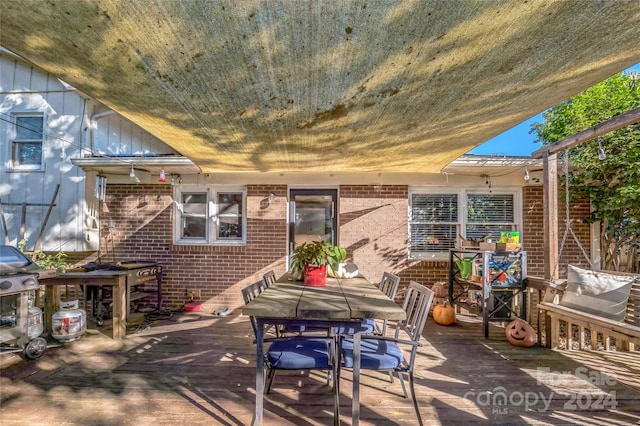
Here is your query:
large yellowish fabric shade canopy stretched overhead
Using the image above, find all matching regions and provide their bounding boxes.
[0,0,640,173]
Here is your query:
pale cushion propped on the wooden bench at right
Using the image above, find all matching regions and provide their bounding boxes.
[560,265,635,321]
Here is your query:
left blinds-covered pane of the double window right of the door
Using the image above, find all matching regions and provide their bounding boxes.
[409,194,459,256]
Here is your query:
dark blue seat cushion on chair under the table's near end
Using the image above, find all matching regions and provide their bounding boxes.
[267,340,331,370]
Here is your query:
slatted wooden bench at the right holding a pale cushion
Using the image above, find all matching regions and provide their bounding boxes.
[538,274,640,351]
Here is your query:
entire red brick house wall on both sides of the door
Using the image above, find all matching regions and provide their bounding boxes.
[100,184,589,312]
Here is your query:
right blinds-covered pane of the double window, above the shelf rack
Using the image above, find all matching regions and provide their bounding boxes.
[465,194,517,241]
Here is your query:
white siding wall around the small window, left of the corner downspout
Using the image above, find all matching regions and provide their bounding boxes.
[0,52,89,251]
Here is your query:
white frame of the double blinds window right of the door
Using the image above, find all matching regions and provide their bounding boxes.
[407,187,523,260]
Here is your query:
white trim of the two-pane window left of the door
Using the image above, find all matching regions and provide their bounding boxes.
[173,184,247,246]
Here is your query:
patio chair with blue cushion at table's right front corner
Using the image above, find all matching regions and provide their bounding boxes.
[340,281,434,425]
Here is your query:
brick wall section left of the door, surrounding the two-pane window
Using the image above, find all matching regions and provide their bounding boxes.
[101,185,287,312]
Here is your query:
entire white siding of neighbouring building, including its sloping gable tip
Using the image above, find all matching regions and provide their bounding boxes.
[0,50,175,252]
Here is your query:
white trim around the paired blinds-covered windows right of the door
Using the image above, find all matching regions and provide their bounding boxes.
[407,187,523,260]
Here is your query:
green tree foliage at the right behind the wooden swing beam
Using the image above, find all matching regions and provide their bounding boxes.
[531,73,640,270]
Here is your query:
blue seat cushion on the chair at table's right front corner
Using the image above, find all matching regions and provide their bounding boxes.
[342,339,404,370]
